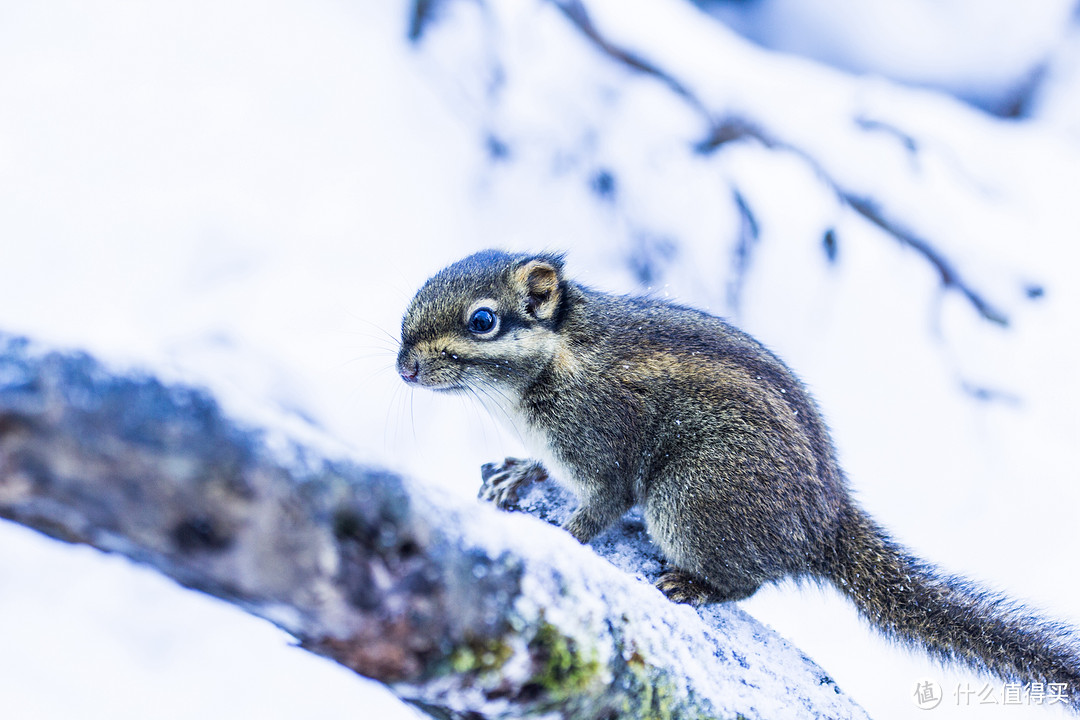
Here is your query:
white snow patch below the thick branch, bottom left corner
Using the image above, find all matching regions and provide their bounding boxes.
[0,522,422,719]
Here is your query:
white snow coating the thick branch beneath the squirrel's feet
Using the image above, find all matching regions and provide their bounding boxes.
[435,480,865,718]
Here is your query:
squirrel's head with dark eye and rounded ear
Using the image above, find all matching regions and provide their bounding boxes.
[397,250,566,393]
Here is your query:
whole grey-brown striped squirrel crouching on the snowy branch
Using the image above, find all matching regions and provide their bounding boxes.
[396,250,1080,712]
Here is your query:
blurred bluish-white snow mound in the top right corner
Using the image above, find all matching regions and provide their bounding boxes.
[699,0,1076,110]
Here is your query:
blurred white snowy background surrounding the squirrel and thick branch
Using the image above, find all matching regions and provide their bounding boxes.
[0,0,1080,720]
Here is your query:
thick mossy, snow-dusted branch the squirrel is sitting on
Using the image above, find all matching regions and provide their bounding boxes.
[0,336,865,718]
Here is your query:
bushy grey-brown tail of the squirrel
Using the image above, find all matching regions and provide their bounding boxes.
[825,505,1080,714]
